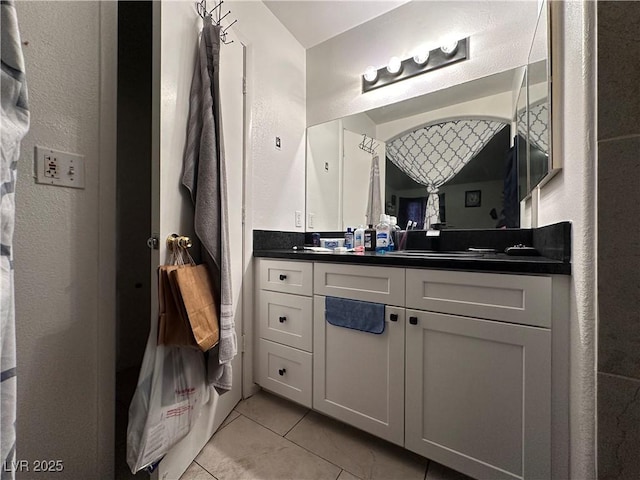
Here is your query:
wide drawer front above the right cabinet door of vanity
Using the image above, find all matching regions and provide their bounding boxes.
[407,269,551,328]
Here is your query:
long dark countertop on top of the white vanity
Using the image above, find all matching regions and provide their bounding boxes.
[253,249,571,275]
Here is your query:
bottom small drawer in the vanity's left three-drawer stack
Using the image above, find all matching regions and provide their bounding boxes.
[258,338,312,408]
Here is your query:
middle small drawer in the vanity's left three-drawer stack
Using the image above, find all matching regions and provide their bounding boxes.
[256,290,313,352]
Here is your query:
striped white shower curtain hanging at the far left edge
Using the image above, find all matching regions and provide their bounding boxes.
[0,0,29,480]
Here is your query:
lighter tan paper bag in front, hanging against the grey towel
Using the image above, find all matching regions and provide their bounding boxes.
[169,265,220,352]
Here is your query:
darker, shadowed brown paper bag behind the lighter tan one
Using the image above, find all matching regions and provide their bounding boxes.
[158,265,198,348]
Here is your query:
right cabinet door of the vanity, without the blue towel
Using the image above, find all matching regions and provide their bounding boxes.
[405,309,551,480]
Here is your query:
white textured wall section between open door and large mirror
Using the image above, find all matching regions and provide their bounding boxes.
[231,1,306,232]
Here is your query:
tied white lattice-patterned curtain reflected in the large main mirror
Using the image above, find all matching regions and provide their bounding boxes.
[387,120,506,228]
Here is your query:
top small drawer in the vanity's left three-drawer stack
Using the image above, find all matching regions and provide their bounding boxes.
[257,258,313,296]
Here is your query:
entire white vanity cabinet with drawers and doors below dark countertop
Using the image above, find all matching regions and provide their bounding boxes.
[256,259,568,480]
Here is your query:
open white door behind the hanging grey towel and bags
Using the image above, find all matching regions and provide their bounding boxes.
[151,1,244,479]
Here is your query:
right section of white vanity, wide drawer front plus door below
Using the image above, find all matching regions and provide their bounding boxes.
[405,269,551,480]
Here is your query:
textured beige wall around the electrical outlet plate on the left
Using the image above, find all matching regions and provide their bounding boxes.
[15,2,115,479]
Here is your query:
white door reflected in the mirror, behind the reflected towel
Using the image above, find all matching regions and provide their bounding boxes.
[342,129,386,230]
